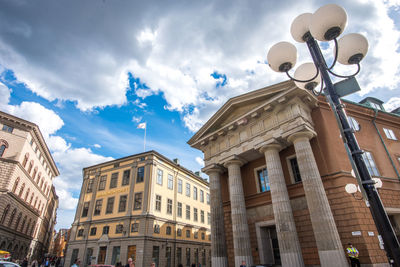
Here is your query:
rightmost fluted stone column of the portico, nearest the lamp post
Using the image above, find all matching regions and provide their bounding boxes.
[288,132,348,267]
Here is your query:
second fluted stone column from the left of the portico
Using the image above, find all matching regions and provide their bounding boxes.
[224,157,253,267]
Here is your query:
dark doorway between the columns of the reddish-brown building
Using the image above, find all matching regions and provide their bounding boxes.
[259,226,281,265]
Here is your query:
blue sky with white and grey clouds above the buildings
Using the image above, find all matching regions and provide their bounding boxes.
[0,0,400,229]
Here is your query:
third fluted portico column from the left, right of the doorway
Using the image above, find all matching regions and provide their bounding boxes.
[260,144,304,267]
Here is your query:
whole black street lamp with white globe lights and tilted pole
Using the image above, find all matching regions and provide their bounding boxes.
[267,4,400,267]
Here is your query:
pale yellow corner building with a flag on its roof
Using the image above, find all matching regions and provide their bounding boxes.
[65,151,210,266]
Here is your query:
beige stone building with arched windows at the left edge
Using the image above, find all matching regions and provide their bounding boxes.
[0,112,59,259]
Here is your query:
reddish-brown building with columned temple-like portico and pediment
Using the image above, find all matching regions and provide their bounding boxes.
[188,81,400,267]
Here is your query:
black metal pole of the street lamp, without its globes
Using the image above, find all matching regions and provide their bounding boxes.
[306,35,400,267]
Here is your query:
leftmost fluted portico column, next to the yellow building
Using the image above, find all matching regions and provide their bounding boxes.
[202,164,228,267]
